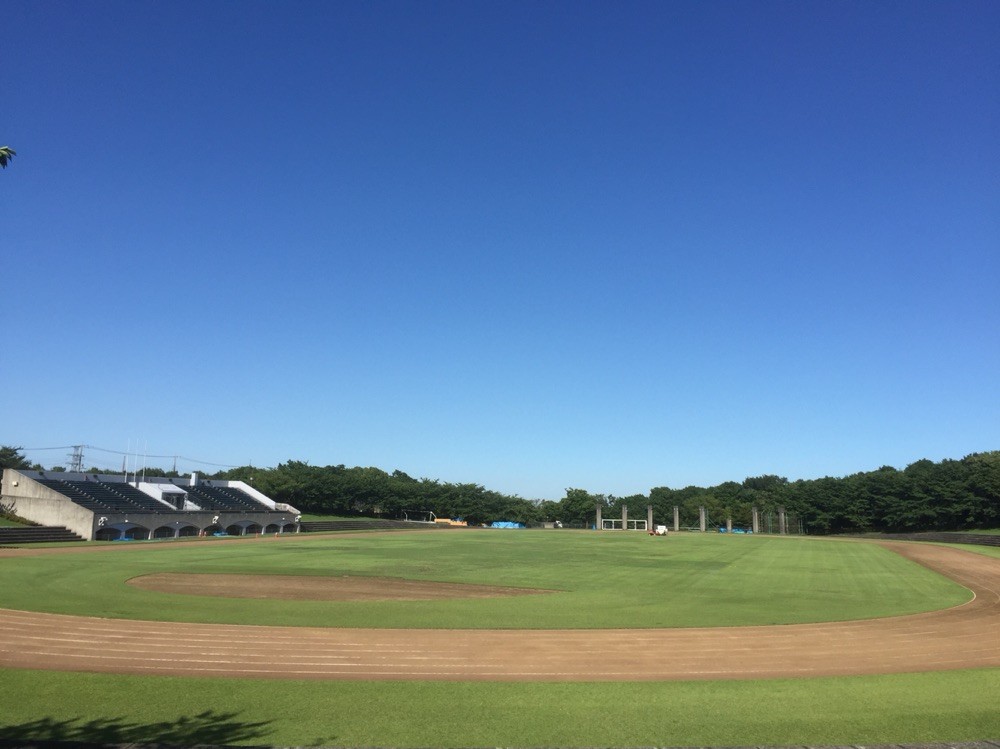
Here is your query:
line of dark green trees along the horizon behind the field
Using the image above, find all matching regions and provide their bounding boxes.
[0,447,1000,534]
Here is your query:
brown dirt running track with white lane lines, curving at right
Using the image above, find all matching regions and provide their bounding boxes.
[0,543,1000,681]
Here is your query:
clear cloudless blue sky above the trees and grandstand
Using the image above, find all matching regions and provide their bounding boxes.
[0,0,1000,499]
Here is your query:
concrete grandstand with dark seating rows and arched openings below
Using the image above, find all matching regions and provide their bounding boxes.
[2,468,300,541]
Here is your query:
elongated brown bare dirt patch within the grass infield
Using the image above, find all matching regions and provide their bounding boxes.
[128,572,552,601]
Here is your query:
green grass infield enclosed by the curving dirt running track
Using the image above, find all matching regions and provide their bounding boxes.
[0,531,969,628]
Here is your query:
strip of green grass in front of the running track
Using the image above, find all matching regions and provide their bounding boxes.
[0,669,1000,747]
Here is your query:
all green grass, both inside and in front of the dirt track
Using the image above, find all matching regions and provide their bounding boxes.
[0,531,1000,747]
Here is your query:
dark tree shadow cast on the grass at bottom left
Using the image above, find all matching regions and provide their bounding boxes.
[0,710,271,749]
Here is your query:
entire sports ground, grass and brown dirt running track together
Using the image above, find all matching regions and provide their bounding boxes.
[0,531,1000,746]
